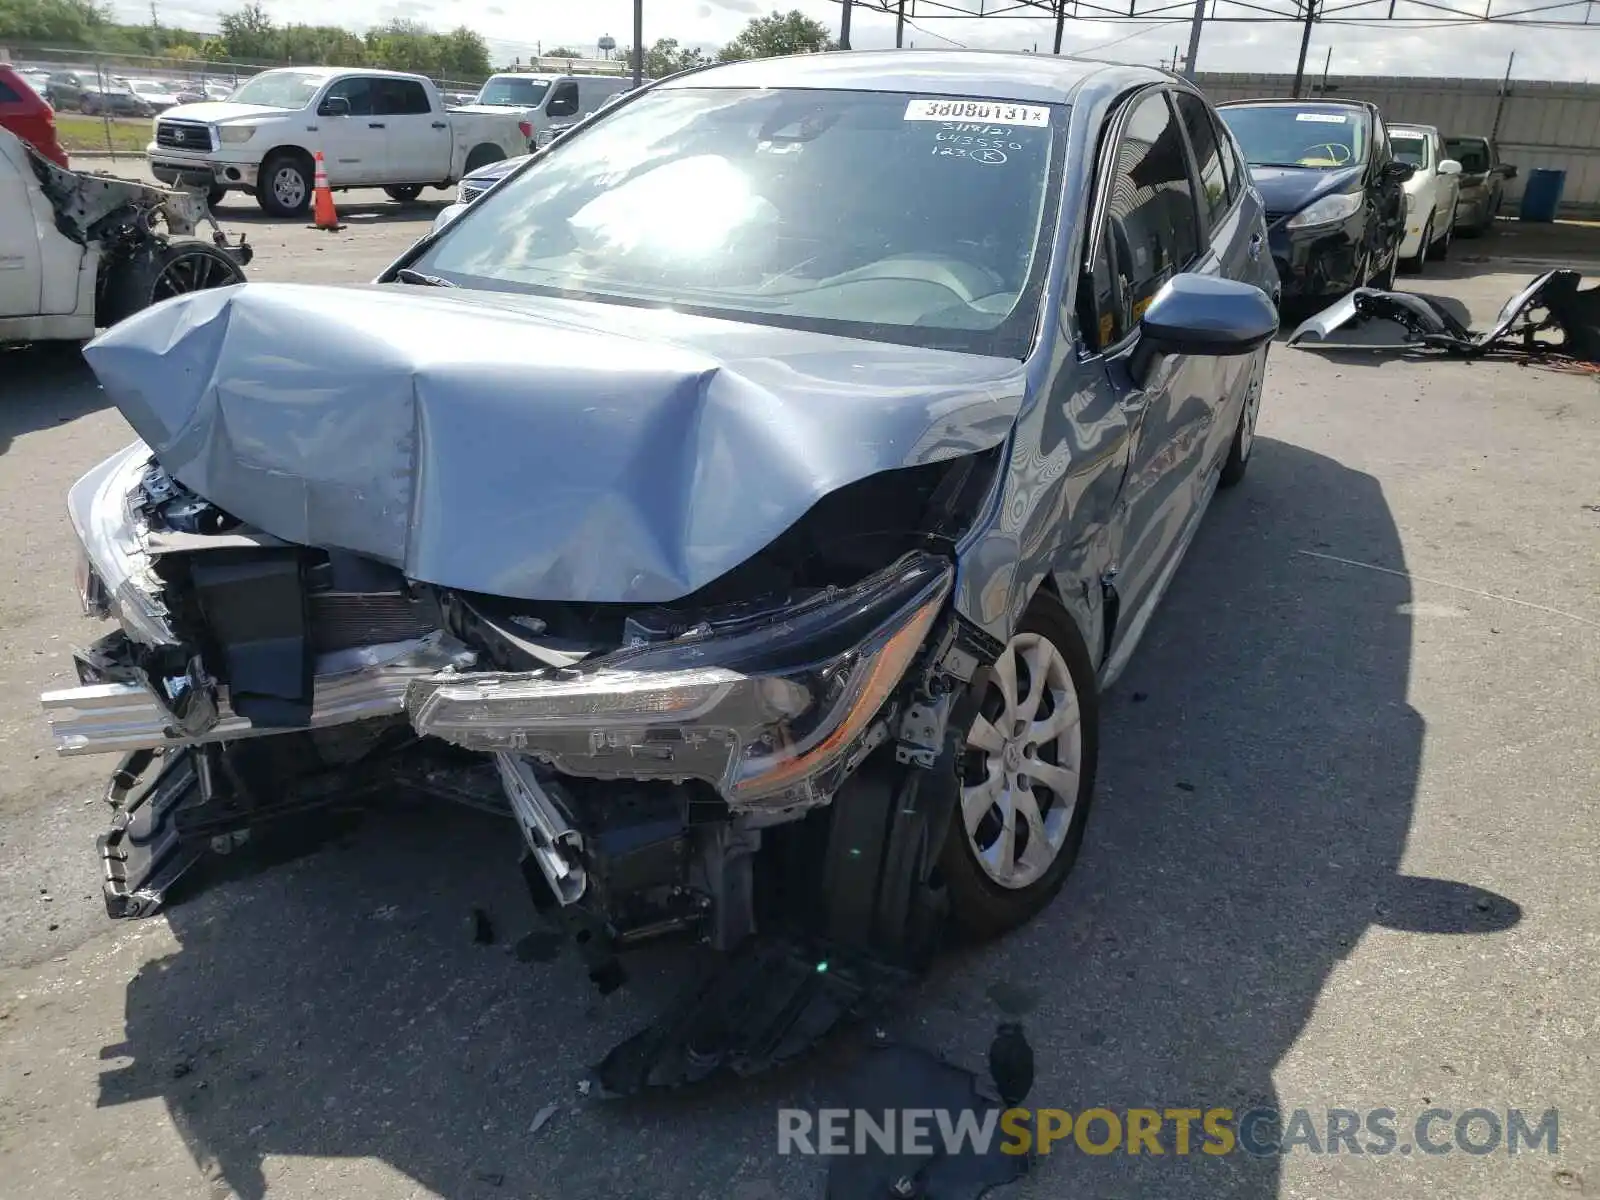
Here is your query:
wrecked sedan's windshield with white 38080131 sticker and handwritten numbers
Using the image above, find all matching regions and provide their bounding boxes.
[411,88,1064,357]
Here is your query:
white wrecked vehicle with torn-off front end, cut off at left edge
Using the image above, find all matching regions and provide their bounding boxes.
[0,130,250,344]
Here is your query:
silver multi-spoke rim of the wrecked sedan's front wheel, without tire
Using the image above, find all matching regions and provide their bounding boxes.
[962,634,1083,890]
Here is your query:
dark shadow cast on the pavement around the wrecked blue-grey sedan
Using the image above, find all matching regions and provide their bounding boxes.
[99,440,1520,1200]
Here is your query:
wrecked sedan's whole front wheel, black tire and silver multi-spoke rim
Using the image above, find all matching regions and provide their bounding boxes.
[939,592,1099,938]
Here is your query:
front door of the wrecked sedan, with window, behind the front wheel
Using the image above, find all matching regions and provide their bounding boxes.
[1094,86,1216,659]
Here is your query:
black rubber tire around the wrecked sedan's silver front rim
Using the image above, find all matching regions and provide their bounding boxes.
[939,590,1099,939]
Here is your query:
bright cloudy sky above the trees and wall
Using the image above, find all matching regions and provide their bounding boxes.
[112,0,1600,82]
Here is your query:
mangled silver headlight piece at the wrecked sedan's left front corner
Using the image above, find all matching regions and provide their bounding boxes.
[67,443,174,646]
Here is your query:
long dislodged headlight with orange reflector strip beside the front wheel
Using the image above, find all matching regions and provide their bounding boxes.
[406,554,954,808]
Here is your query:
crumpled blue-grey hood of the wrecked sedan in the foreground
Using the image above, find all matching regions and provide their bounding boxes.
[85,283,1024,603]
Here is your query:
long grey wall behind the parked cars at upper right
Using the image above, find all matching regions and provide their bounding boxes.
[1198,72,1600,216]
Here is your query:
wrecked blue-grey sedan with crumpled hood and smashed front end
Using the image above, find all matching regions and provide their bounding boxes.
[43,53,1277,1091]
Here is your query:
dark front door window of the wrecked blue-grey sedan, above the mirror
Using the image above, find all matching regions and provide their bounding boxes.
[1106,93,1200,336]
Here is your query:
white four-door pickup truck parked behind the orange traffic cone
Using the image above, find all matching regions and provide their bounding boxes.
[146,67,531,216]
